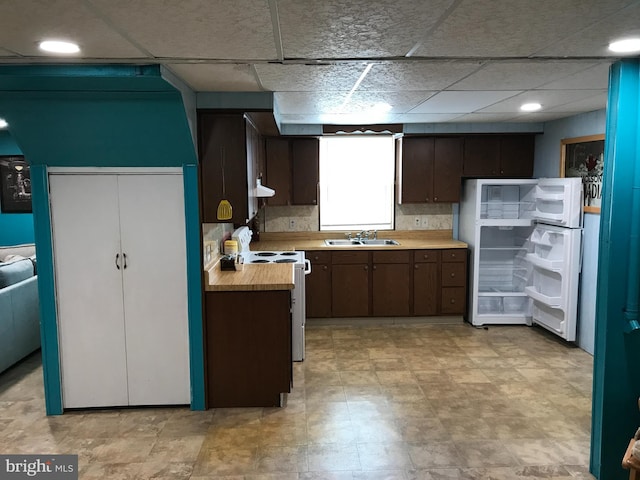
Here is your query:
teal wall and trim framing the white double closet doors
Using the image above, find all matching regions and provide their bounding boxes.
[0,65,204,414]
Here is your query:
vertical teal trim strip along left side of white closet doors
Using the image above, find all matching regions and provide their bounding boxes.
[31,165,63,415]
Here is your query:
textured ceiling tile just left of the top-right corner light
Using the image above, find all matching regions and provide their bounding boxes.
[416,0,632,57]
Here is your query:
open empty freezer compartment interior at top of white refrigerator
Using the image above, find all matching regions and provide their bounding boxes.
[480,185,535,220]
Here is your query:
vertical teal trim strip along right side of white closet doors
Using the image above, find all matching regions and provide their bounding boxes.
[183,165,206,410]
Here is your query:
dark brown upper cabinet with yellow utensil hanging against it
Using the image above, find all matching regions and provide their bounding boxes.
[198,114,249,224]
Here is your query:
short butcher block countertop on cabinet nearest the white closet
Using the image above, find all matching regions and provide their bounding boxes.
[204,261,293,292]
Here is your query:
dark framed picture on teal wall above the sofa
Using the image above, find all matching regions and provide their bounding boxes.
[0,156,31,213]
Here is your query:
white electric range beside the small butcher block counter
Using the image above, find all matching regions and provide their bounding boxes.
[232,227,311,362]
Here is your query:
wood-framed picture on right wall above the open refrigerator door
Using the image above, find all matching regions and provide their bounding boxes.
[560,134,604,213]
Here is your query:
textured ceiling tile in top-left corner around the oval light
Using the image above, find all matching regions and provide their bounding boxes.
[0,0,147,59]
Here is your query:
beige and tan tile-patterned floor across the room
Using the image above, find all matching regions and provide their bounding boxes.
[0,324,593,480]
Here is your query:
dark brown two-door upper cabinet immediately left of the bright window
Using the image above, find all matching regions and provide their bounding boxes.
[264,137,320,205]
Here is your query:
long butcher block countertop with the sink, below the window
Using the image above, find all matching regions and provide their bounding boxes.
[251,230,468,251]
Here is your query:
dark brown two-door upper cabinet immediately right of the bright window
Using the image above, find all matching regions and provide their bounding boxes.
[398,136,463,203]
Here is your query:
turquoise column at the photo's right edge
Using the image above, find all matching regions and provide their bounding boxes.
[590,59,640,480]
